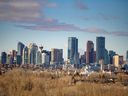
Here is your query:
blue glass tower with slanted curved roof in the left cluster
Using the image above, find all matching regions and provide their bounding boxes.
[17,42,24,64]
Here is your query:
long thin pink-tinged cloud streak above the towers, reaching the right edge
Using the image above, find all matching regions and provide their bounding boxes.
[18,20,128,36]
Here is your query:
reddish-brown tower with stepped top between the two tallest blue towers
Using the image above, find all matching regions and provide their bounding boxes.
[86,41,94,64]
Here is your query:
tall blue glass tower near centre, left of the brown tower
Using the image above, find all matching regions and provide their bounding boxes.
[68,37,79,64]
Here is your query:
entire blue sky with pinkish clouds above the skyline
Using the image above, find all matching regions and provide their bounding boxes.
[0,0,128,58]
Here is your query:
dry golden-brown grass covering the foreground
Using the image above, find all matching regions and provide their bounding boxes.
[0,69,128,96]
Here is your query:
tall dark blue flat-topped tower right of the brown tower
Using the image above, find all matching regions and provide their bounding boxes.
[96,37,105,63]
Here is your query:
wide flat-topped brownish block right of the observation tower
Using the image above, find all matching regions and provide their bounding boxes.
[51,48,63,64]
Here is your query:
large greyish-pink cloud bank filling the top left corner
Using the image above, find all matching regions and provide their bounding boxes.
[0,0,57,23]
